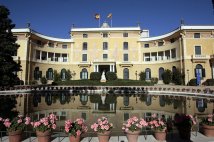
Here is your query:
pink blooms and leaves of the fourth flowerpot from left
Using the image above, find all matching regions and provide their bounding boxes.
[91,117,113,133]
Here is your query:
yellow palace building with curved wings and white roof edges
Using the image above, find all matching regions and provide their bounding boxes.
[12,23,214,84]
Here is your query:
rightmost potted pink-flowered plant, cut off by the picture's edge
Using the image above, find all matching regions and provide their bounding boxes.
[201,114,214,137]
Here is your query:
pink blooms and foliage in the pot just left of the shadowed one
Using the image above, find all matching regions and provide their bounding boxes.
[148,114,167,131]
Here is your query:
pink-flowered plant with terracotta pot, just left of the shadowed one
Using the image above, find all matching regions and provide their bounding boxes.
[148,114,167,141]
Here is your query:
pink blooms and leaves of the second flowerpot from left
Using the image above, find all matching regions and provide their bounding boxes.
[31,114,57,132]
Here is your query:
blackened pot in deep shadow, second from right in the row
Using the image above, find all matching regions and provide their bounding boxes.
[178,125,191,141]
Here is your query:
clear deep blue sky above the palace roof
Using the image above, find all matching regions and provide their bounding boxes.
[0,0,214,38]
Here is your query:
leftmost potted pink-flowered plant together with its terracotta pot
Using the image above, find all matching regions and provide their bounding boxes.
[1,115,31,142]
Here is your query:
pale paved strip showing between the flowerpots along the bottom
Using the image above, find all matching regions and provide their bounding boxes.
[1,132,214,142]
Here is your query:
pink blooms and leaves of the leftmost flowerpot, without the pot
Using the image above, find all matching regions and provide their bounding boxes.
[0,115,31,132]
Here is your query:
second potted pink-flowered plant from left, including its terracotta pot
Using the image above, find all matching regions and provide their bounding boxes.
[31,114,57,142]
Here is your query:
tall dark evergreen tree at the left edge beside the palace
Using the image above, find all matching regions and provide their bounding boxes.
[0,5,21,86]
